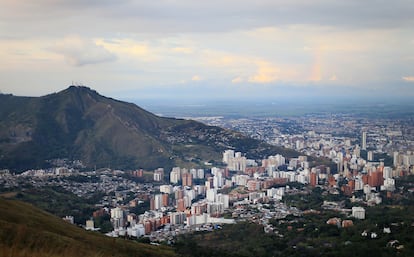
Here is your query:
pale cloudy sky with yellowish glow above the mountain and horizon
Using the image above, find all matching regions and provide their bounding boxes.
[0,0,414,99]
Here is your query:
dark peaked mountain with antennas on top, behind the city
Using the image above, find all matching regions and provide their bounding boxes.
[0,86,299,171]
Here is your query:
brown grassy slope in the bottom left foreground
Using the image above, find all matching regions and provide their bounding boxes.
[0,197,175,257]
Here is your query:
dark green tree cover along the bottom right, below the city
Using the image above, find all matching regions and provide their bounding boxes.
[176,207,414,257]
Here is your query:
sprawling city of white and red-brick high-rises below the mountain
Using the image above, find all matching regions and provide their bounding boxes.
[0,114,414,252]
